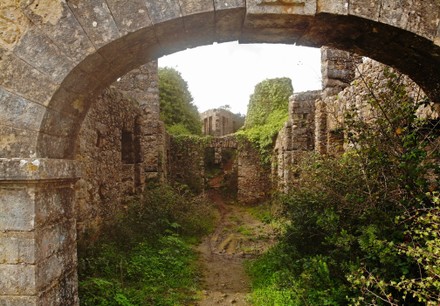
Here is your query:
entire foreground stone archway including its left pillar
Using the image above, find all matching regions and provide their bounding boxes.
[0,0,440,305]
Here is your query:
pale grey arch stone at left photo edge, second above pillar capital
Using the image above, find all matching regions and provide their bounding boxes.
[0,87,46,130]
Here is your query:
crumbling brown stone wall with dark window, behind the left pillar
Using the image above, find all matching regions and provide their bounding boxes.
[76,62,166,239]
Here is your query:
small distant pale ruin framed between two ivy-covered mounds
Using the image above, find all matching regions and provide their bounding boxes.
[200,108,244,137]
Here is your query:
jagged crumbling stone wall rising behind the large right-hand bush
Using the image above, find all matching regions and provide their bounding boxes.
[272,47,438,191]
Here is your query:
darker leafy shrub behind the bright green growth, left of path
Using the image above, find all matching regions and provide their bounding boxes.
[100,184,215,247]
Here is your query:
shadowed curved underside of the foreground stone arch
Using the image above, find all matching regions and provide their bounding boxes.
[37,14,440,159]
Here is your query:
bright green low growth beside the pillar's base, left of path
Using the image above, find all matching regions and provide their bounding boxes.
[79,235,200,305]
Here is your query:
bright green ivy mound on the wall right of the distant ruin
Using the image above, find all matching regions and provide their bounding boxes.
[237,78,293,163]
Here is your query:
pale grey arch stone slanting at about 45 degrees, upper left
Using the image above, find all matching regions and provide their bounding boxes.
[14,28,74,84]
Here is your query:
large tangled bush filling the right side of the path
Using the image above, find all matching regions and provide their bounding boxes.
[249,71,440,305]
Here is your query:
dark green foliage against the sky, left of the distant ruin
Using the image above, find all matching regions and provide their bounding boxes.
[159,68,202,135]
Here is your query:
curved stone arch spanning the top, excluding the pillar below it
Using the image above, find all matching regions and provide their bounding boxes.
[0,0,440,159]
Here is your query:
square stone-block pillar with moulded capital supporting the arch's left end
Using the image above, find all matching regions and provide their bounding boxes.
[0,158,80,306]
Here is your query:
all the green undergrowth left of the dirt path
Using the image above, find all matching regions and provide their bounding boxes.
[78,185,215,306]
